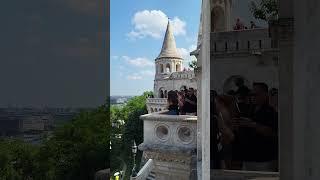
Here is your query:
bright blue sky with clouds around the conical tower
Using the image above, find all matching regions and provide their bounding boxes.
[110,0,201,95]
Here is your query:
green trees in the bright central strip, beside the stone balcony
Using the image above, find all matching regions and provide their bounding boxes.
[111,91,152,179]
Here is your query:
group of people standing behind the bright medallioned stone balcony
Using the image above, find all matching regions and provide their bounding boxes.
[168,88,197,115]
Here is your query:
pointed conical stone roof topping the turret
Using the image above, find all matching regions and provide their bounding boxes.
[157,20,182,59]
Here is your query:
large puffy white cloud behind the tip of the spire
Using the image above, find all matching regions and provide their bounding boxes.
[127,10,186,39]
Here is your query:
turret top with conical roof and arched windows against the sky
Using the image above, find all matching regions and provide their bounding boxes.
[155,20,183,80]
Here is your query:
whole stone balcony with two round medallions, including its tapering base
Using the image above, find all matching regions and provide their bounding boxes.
[139,111,197,180]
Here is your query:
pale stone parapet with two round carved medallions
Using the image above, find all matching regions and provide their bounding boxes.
[139,111,197,153]
